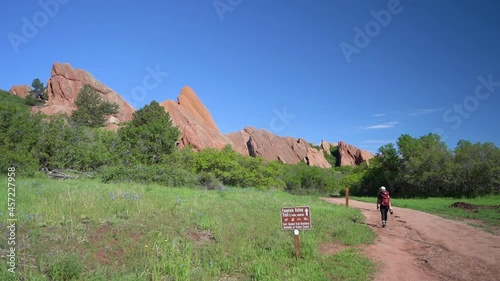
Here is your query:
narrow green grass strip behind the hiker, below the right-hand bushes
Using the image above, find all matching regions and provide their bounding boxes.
[351,195,500,232]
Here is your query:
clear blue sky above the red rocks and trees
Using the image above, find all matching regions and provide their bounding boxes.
[0,0,500,152]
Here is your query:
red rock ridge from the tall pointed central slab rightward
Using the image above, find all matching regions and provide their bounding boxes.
[160,87,369,168]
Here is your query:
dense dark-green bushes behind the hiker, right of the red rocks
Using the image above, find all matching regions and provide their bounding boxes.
[356,134,500,197]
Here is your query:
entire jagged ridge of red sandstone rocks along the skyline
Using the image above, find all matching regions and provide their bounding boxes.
[10,63,373,168]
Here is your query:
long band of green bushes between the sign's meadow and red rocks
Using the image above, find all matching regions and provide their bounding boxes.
[0,93,348,194]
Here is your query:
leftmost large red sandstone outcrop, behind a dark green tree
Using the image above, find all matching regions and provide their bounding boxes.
[37,63,135,127]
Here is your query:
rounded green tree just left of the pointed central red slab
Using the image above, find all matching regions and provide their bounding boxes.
[118,101,180,165]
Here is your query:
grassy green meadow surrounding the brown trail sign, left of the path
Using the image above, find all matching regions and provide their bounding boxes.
[0,177,374,280]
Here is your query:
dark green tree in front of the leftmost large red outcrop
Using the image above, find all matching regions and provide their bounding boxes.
[71,85,118,128]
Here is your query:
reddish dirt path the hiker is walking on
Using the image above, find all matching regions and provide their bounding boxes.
[322,198,500,281]
